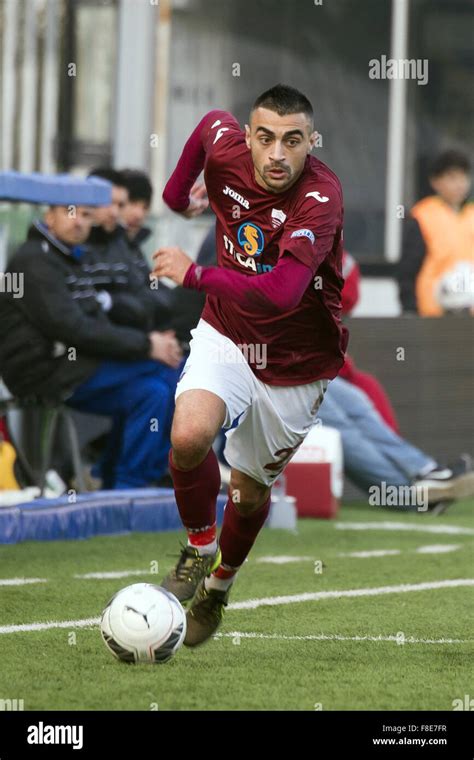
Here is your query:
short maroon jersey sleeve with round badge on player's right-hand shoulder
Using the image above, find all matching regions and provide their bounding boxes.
[279,186,343,274]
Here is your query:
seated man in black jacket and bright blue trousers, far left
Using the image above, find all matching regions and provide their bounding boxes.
[0,206,182,488]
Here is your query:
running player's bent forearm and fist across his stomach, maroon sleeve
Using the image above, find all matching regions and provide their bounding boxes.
[153,246,313,313]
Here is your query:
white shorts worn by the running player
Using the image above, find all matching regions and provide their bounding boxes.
[175,319,329,486]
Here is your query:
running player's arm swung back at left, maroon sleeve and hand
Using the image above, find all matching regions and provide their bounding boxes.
[163,110,240,218]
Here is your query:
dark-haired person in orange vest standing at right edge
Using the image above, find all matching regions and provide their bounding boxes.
[398,150,474,317]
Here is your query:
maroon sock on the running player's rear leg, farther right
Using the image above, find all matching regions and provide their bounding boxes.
[219,496,271,567]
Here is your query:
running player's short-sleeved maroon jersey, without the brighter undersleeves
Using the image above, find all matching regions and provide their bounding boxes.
[174,111,348,386]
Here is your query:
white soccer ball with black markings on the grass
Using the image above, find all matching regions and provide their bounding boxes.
[100,583,186,663]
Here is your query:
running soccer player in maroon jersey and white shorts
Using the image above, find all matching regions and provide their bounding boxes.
[153,85,348,646]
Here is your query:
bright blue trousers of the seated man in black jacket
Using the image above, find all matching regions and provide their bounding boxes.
[66,360,184,488]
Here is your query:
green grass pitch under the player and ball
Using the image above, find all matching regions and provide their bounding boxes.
[0,501,474,710]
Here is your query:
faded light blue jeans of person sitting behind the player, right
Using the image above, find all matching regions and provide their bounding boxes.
[318,377,436,490]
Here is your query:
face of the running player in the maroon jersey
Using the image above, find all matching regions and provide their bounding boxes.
[245,108,318,193]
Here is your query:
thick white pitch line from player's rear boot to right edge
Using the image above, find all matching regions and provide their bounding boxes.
[227,578,474,610]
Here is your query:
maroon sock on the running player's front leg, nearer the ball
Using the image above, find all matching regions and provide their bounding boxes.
[169,448,221,543]
